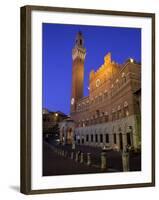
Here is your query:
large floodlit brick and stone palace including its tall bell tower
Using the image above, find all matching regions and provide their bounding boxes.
[59,32,141,149]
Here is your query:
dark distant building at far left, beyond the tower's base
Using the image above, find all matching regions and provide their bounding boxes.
[42,108,68,134]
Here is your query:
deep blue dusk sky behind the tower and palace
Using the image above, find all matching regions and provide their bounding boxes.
[42,23,141,114]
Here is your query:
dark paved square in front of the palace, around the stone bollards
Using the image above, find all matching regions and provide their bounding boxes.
[43,140,141,176]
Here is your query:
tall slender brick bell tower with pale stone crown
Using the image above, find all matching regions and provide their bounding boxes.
[71,31,86,114]
